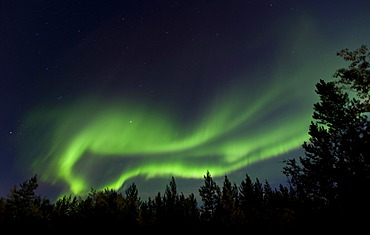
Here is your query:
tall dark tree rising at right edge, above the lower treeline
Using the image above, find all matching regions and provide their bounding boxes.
[284,46,370,228]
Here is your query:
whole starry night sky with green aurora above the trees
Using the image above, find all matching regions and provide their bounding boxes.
[0,0,370,199]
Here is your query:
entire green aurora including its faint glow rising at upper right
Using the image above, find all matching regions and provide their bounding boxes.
[17,14,352,195]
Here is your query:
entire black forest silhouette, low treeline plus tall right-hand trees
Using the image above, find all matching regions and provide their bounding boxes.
[0,46,370,232]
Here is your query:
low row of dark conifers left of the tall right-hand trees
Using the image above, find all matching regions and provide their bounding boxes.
[0,172,320,231]
